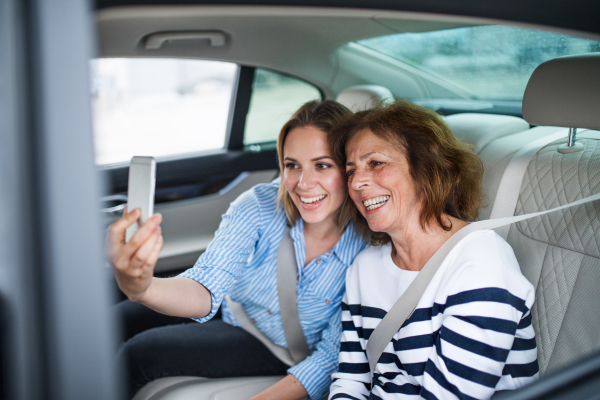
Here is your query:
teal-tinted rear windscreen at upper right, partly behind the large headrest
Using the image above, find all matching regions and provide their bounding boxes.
[357,26,600,100]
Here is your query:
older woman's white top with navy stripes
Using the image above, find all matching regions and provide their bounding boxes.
[329,231,538,400]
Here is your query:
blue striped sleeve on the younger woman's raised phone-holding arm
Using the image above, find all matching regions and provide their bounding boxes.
[179,187,263,322]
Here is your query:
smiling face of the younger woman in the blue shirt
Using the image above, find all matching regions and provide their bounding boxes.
[283,126,348,228]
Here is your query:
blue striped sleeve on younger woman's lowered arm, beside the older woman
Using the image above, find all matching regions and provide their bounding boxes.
[288,308,342,400]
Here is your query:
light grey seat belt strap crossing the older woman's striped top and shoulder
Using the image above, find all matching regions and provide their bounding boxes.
[366,193,600,384]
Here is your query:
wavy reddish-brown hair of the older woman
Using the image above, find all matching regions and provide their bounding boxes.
[330,101,484,245]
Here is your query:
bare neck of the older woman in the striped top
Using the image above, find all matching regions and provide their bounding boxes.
[390,214,467,271]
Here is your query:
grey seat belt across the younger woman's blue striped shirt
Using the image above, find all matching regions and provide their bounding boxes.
[225,227,311,367]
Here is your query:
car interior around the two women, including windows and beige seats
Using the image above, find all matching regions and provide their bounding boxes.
[0,0,600,400]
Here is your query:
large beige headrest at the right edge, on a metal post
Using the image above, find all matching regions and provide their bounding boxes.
[523,53,600,129]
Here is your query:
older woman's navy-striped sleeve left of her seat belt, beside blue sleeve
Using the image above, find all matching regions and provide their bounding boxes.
[329,293,371,400]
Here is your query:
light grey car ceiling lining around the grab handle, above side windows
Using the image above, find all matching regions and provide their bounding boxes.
[96,0,600,97]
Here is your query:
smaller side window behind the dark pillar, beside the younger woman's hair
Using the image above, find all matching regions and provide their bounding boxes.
[244,68,321,145]
